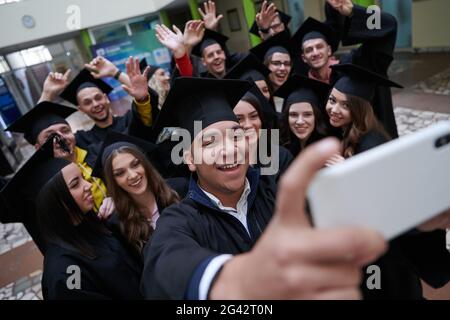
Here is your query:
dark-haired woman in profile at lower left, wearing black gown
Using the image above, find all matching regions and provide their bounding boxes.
[35,156,142,299]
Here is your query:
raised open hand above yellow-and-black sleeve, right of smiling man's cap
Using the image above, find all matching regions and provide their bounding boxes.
[122,57,150,102]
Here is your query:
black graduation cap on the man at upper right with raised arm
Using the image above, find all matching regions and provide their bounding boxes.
[291,17,339,52]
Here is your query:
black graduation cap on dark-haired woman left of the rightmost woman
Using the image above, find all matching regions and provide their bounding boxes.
[275,74,332,110]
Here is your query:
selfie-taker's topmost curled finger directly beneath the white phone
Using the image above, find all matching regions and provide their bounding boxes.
[292,228,387,267]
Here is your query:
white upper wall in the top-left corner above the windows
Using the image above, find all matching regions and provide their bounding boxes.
[0,0,174,48]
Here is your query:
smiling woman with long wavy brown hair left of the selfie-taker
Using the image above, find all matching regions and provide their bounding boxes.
[100,135,184,254]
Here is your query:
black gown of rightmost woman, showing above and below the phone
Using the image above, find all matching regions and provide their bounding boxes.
[355,131,450,300]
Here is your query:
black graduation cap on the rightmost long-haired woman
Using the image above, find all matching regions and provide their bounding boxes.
[331,63,403,102]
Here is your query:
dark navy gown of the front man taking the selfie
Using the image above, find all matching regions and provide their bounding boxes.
[141,168,275,299]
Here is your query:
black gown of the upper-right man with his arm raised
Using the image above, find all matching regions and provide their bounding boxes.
[326,4,398,138]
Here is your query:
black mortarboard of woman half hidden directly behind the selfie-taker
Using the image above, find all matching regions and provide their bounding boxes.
[224,52,270,81]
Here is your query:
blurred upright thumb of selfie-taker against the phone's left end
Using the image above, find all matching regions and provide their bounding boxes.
[274,138,340,227]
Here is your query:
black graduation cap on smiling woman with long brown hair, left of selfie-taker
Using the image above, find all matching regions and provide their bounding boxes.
[92,131,158,178]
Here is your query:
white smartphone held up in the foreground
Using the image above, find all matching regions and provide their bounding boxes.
[308,121,450,240]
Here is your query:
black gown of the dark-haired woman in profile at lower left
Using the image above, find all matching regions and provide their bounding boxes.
[42,220,142,300]
